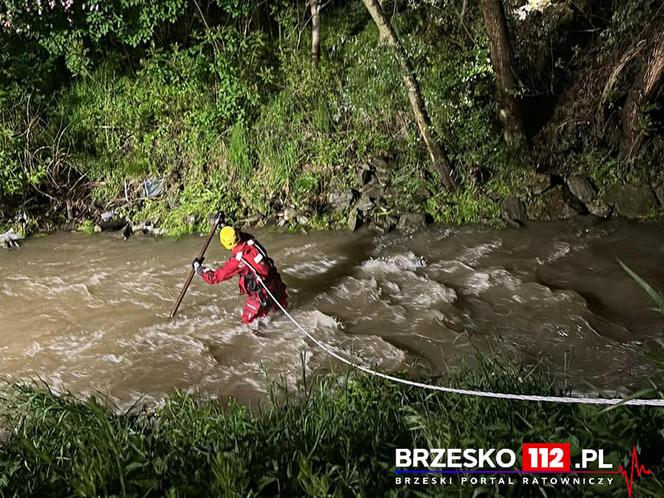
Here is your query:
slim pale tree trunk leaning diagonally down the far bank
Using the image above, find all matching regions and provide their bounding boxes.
[362,0,456,190]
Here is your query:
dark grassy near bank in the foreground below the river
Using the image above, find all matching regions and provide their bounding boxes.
[0,360,664,497]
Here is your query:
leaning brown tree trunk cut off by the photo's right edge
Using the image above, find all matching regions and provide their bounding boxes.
[623,33,664,160]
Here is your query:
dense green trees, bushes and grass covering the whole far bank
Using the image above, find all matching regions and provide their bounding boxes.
[0,0,664,233]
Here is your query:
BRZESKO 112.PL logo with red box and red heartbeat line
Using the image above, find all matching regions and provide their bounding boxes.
[394,443,654,498]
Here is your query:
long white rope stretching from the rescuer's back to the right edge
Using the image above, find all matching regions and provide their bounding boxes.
[248,258,664,407]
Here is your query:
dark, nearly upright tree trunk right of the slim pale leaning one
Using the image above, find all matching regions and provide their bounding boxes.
[481,0,526,146]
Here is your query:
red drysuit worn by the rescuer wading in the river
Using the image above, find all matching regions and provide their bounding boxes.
[201,233,288,323]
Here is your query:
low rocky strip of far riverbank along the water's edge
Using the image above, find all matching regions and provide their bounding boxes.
[5,167,664,246]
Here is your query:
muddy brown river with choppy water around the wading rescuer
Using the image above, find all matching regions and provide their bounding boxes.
[0,220,664,406]
